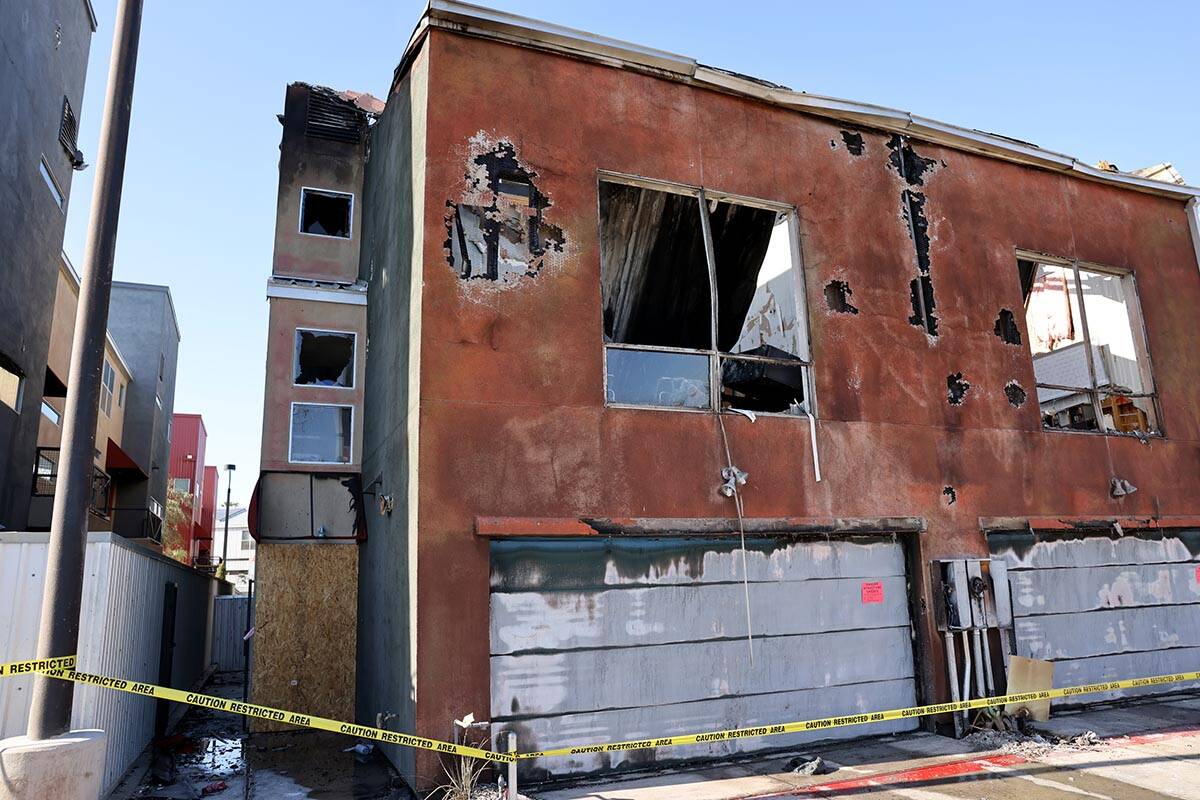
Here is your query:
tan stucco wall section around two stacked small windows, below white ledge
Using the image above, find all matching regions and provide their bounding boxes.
[262,297,367,473]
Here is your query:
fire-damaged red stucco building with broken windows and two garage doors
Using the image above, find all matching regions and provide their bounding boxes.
[255,0,1200,788]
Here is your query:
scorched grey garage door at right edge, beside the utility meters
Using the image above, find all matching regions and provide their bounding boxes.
[989,531,1200,703]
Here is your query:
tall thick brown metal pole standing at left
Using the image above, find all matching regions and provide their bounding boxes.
[28,0,142,739]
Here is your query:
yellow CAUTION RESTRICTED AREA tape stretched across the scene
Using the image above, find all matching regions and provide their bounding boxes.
[0,656,1200,763]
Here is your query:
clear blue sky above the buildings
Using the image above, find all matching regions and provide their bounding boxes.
[66,0,1200,501]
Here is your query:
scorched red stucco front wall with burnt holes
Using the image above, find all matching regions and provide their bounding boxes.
[398,30,1200,786]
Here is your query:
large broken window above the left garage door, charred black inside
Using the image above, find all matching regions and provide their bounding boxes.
[600,180,809,414]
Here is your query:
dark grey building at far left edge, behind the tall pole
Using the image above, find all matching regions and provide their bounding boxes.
[0,0,96,529]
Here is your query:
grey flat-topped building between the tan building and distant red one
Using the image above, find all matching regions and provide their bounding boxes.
[108,281,179,542]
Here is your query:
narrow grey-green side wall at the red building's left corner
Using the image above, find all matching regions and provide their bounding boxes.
[358,48,429,783]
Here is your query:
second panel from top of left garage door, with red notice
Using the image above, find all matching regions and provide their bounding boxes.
[492,576,908,654]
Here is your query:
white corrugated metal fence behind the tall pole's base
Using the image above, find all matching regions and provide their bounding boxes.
[0,533,221,793]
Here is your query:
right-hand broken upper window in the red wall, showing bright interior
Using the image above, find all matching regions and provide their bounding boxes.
[1018,257,1159,434]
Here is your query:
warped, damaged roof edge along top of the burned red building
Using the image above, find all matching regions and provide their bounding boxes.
[391,0,1200,200]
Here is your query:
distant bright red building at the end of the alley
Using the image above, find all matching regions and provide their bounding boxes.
[168,414,216,565]
